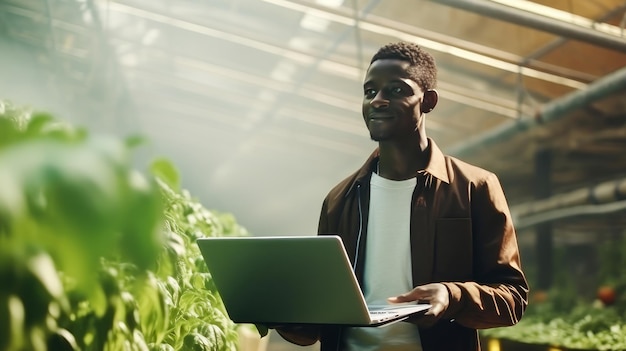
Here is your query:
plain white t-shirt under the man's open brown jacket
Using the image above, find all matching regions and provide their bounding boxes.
[344,173,422,351]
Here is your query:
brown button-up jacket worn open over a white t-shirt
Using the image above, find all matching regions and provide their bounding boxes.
[318,139,528,351]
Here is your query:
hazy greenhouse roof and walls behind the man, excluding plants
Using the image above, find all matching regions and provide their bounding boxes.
[0,0,626,347]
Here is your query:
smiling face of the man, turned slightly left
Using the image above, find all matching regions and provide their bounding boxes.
[363,59,424,141]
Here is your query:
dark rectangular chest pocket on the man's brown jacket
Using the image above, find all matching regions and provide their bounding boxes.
[434,218,474,281]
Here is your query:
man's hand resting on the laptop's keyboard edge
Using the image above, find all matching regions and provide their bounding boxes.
[387,283,450,325]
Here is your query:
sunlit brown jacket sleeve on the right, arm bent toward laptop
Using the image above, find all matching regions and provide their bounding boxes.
[444,173,528,329]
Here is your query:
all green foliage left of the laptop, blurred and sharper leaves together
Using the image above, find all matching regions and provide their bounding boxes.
[0,103,247,351]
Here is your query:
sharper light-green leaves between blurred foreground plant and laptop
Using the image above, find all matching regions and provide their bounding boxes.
[151,159,249,350]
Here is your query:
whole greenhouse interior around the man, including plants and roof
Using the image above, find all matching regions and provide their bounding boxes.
[0,0,626,351]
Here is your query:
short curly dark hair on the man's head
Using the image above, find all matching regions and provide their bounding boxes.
[370,41,437,91]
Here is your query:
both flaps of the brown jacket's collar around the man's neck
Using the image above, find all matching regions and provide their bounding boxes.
[348,138,450,193]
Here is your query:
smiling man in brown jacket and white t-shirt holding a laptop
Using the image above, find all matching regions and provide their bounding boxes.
[277,42,528,351]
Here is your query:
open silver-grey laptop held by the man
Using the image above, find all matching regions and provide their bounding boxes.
[197,236,430,326]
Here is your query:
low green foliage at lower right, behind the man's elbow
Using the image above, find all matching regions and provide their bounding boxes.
[481,237,626,350]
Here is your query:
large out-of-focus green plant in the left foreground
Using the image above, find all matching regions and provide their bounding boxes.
[0,103,162,350]
